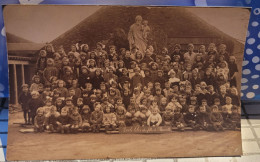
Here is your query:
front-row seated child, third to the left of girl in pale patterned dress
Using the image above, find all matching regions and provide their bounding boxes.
[70,107,82,133]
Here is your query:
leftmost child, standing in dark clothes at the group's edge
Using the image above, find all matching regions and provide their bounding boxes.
[18,84,32,124]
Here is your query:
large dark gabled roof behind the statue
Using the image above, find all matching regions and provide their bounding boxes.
[52,6,243,52]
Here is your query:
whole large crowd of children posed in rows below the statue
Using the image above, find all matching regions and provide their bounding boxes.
[19,39,240,133]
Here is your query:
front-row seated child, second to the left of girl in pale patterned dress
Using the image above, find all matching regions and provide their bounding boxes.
[81,105,91,132]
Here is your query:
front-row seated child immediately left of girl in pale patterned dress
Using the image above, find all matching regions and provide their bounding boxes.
[90,103,103,133]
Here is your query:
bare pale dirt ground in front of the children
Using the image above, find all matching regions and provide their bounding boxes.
[7,112,242,160]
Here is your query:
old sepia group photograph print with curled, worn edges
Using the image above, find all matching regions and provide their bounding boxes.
[3,5,250,160]
